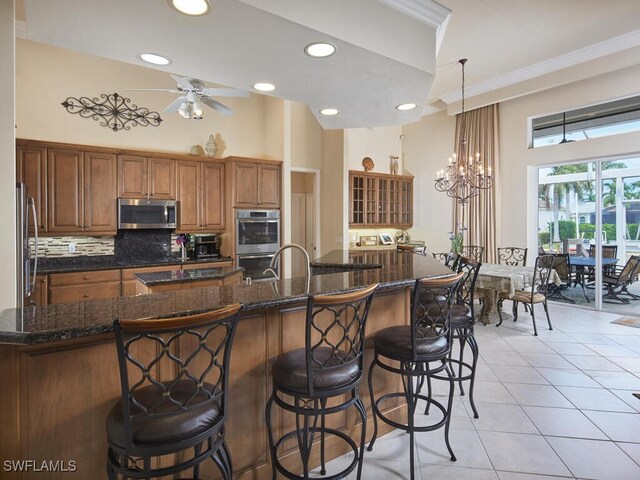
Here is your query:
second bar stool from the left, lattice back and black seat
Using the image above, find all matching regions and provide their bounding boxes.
[265,284,378,480]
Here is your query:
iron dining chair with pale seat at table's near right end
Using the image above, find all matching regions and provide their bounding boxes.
[496,255,556,336]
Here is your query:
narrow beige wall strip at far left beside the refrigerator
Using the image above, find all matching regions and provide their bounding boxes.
[0,0,16,310]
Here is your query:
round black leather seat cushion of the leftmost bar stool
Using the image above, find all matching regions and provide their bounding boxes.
[107,380,222,447]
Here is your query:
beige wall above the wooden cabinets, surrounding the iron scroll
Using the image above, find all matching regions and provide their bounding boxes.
[16,40,266,157]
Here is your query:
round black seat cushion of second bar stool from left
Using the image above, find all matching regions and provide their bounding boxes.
[272,347,360,393]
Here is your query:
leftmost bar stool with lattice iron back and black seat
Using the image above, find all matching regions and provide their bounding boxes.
[106,304,240,480]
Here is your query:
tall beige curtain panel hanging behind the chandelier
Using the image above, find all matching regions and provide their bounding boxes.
[452,104,500,263]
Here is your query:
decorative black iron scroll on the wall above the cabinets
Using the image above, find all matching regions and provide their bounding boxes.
[62,93,162,132]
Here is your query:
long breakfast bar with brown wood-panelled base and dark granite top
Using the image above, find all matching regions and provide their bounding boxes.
[0,251,452,479]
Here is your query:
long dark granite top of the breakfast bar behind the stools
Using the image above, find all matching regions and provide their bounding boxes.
[0,251,453,345]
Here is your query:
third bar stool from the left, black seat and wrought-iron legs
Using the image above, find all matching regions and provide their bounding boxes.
[367,273,463,480]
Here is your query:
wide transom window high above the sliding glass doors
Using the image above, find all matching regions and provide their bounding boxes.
[531,96,640,148]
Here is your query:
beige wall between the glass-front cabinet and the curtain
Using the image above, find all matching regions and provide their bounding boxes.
[402,112,455,252]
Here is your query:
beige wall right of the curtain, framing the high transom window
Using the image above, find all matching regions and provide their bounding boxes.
[498,66,640,255]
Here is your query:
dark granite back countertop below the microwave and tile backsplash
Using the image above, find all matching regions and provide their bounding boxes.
[33,255,232,274]
